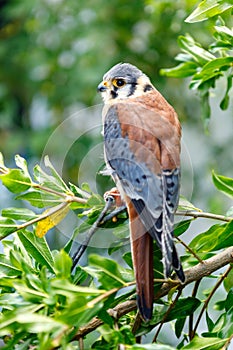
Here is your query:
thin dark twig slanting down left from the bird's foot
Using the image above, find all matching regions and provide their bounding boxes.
[72,196,114,271]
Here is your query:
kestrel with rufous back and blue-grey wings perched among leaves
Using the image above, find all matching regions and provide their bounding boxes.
[97,63,185,321]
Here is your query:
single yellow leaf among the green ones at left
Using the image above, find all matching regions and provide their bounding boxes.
[35,203,70,238]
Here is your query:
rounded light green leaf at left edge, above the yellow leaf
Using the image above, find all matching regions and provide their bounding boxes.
[0,169,31,193]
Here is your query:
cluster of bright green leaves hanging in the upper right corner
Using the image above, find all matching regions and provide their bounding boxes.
[160,0,233,129]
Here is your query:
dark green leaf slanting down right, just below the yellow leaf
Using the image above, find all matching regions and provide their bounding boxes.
[18,231,55,273]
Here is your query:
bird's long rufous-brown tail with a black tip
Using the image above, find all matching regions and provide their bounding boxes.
[128,203,154,321]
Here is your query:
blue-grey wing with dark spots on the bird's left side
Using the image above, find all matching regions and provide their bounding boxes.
[104,107,163,222]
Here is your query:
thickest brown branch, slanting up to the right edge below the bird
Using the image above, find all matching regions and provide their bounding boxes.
[74,247,233,340]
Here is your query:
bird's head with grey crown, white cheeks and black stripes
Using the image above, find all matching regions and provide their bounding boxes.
[98,63,154,103]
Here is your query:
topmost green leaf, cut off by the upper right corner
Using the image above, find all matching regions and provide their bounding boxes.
[185,0,233,23]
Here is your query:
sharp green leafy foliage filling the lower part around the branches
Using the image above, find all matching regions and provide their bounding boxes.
[0,155,233,350]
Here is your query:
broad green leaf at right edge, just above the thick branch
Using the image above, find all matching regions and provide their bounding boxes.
[189,220,233,252]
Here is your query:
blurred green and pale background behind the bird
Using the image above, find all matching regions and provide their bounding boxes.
[0,0,233,246]
